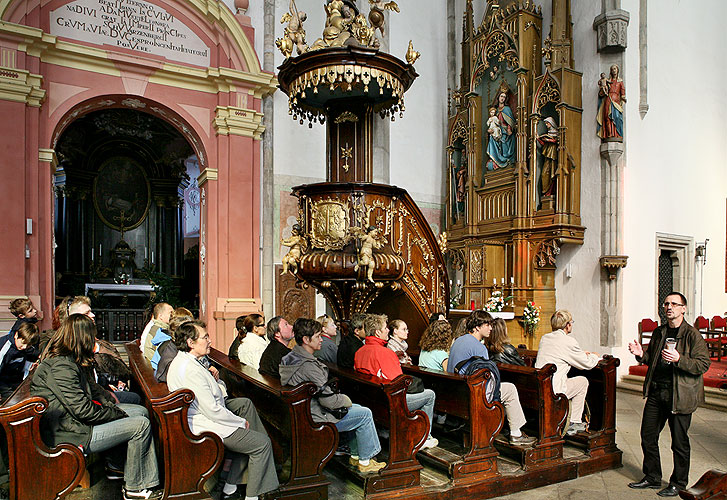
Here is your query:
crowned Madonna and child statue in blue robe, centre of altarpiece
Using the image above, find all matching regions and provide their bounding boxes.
[483,82,516,172]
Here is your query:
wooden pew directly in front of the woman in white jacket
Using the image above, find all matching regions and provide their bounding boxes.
[208,349,338,499]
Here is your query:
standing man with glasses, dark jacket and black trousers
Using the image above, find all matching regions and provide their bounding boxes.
[629,292,710,497]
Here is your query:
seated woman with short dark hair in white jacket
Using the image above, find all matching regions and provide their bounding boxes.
[167,321,278,500]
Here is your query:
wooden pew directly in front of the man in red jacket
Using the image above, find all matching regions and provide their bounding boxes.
[402,365,505,483]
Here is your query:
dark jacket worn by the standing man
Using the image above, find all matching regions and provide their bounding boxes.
[636,321,711,414]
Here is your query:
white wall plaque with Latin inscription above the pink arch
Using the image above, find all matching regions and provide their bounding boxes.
[50,0,210,67]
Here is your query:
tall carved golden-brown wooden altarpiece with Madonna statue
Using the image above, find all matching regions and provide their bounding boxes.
[446,0,585,347]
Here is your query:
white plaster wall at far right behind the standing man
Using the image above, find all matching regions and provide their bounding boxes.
[620,0,727,364]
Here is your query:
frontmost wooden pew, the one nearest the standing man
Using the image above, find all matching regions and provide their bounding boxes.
[518,349,622,476]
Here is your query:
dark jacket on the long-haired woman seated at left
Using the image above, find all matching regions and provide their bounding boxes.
[30,356,127,447]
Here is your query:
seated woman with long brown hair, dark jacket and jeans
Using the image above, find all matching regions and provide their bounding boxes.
[30,314,163,500]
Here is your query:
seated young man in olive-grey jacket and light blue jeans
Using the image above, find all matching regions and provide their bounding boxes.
[280,318,386,473]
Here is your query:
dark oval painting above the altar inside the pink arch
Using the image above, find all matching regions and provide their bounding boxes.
[93,156,151,231]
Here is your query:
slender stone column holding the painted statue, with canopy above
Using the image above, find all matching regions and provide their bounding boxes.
[592,0,629,347]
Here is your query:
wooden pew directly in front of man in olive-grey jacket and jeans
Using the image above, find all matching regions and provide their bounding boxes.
[326,363,429,498]
